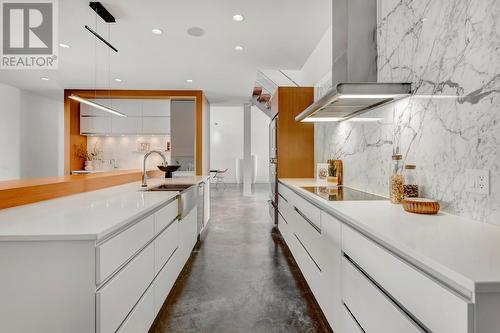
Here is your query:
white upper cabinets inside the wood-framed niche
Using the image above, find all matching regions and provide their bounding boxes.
[80,99,170,135]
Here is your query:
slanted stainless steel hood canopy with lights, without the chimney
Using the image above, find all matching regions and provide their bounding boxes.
[295,83,411,122]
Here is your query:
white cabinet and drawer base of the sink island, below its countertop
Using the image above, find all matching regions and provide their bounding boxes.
[0,190,203,333]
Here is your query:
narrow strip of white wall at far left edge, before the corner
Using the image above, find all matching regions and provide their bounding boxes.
[0,83,21,180]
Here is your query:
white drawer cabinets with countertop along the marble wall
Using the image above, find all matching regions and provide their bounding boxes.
[278,179,500,333]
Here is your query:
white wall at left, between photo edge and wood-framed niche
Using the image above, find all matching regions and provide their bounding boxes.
[0,83,64,180]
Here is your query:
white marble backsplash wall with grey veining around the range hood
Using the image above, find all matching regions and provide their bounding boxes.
[315,0,500,225]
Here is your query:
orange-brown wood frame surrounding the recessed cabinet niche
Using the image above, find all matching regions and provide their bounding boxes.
[64,89,210,175]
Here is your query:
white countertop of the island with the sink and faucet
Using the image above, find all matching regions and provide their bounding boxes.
[0,176,207,241]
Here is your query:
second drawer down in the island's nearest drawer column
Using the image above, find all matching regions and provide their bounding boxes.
[96,244,155,333]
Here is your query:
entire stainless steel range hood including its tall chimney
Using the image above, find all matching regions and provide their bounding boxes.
[295,0,411,121]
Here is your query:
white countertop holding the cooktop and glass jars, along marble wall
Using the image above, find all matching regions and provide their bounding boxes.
[279,179,500,294]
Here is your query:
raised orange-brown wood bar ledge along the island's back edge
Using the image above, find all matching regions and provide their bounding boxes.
[0,170,163,209]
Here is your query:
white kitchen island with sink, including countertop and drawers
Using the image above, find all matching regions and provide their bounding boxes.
[0,177,209,332]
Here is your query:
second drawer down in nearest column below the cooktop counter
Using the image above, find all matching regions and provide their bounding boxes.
[342,258,422,333]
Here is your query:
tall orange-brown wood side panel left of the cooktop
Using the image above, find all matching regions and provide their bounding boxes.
[271,87,314,178]
